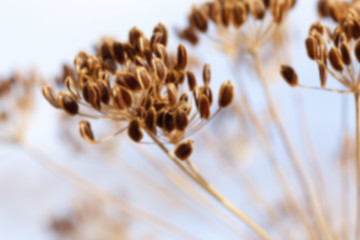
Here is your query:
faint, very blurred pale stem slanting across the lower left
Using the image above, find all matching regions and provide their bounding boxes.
[19,143,197,239]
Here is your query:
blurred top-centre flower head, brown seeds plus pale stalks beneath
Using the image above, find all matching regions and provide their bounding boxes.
[179,0,296,55]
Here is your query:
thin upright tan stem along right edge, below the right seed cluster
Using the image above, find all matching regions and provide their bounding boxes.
[355,93,360,239]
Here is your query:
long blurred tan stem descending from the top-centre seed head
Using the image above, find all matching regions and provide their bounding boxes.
[252,52,333,239]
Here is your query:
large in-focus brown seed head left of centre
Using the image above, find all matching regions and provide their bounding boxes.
[43,24,234,159]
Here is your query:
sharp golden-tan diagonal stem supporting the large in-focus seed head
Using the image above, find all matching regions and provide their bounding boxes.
[145,129,271,240]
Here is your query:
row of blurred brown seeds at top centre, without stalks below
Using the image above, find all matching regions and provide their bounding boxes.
[180,0,296,44]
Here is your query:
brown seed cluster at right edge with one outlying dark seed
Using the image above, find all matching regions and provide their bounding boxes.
[282,2,360,93]
